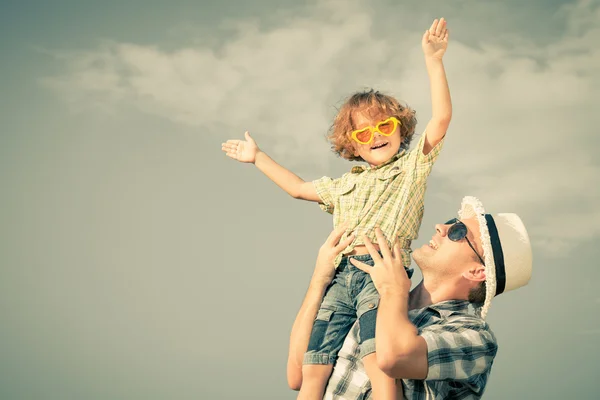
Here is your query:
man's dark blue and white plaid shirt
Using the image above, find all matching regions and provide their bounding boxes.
[323,300,498,400]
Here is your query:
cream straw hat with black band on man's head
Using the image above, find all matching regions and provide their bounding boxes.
[458,196,532,318]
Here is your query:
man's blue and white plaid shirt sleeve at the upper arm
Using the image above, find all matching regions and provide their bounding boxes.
[421,320,498,385]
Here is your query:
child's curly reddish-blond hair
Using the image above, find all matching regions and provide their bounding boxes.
[327,89,417,161]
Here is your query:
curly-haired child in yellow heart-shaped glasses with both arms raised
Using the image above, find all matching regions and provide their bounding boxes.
[222,18,452,400]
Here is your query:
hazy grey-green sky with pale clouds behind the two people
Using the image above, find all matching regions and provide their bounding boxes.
[0,0,600,400]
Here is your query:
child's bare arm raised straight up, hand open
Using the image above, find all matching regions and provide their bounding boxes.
[421,18,452,154]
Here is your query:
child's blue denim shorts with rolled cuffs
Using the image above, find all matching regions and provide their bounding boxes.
[304,254,413,365]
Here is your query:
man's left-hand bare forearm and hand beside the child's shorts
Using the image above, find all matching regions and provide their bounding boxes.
[287,223,354,390]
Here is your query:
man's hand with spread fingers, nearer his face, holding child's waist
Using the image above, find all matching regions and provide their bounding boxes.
[350,228,410,296]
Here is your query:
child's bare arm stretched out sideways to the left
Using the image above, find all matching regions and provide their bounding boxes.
[221,132,321,202]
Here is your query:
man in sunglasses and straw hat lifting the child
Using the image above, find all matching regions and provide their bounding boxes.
[287,196,532,399]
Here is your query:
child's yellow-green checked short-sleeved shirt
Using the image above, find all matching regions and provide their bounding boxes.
[313,134,444,267]
